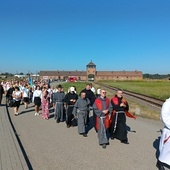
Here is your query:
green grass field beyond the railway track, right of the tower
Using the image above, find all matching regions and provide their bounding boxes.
[100,80,170,100]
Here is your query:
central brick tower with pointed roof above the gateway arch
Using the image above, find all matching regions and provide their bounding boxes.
[86,61,96,81]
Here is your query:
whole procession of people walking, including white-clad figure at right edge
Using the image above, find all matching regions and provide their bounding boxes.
[0,78,170,170]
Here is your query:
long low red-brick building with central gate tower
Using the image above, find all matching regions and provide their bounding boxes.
[39,61,143,81]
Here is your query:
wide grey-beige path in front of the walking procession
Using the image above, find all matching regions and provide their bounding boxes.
[9,101,163,170]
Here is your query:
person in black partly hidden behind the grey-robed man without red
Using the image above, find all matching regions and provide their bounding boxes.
[80,84,96,125]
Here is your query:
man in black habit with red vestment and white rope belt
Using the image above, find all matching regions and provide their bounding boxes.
[109,89,129,144]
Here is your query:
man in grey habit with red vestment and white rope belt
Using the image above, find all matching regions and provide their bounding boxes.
[93,89,110,149]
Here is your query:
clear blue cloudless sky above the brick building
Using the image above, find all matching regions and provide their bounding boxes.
[0,0,170,74]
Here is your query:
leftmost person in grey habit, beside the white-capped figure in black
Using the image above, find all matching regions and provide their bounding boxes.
[53,84,65,123]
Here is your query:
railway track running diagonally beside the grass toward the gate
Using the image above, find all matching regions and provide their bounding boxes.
[95,83,164,108]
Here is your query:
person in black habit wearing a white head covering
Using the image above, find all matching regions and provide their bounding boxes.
[65,87,78,128]
